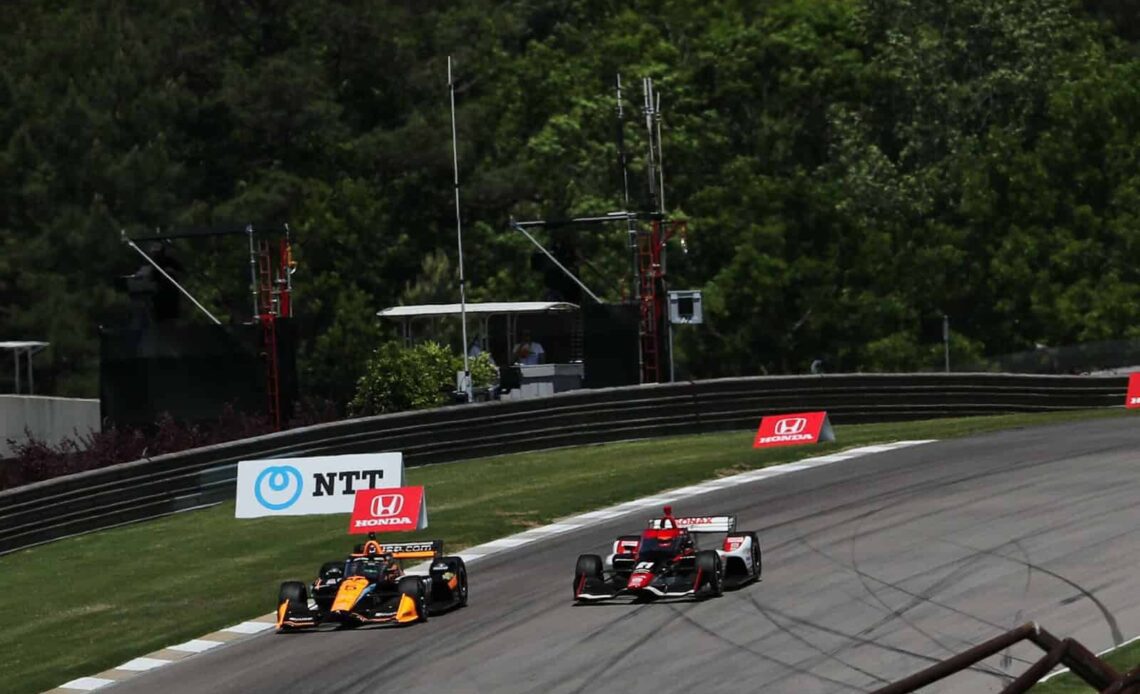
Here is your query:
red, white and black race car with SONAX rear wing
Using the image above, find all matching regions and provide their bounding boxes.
[573,506,760,603]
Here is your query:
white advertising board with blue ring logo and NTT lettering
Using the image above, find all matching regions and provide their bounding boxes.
[234,452,404,519]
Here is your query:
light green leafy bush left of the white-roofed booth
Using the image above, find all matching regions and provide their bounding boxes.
[349,342,497,416]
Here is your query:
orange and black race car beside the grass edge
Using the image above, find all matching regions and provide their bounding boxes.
[277,533,467,632]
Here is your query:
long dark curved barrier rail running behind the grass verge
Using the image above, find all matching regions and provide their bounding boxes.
[0,374,1126,554]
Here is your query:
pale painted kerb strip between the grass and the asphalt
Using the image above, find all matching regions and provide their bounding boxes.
[51,440,933,693]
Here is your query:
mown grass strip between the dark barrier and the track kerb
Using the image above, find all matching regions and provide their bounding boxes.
[0,410,1124,692]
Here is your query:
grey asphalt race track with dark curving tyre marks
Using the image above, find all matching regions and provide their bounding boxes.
[106,417,1140,694]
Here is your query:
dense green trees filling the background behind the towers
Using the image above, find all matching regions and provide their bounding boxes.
[0,0,1140,399]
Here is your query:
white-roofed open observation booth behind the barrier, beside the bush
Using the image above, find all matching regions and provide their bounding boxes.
[376,301,585,400]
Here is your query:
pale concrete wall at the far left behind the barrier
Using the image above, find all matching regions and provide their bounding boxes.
[0,395,100,458]
